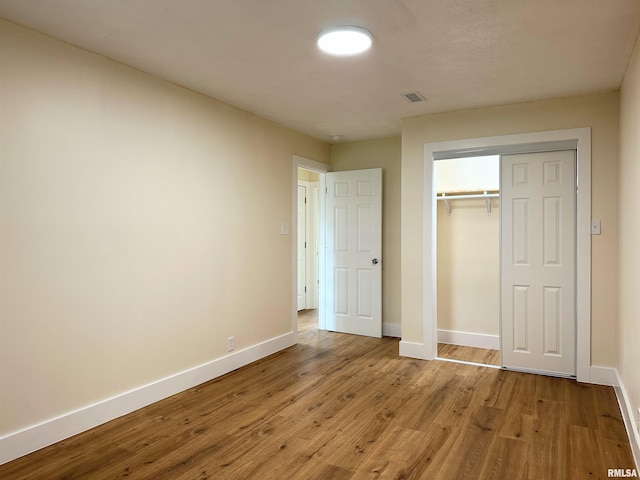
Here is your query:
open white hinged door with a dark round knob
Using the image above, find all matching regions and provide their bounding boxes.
[326,168,382,337]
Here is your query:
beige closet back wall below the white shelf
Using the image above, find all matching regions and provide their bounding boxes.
[437,199,500,335]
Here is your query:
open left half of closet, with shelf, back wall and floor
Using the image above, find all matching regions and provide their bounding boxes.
[434,155,501,367]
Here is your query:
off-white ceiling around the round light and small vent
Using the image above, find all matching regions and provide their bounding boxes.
[0,0,640,141]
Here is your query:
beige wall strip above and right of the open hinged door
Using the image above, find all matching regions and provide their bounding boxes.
[331,137,401,324]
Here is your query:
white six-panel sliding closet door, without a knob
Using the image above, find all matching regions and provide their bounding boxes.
[500,150,576,375]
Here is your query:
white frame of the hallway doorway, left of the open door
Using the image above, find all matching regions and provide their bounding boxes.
[290,155,332,343]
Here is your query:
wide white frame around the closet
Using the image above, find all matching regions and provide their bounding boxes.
[420,127,591,382]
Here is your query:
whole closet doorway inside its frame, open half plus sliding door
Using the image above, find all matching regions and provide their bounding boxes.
[434,150,576,376]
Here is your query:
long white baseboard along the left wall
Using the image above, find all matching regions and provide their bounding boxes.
[0,332,295,465]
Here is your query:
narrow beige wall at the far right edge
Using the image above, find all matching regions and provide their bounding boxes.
[618,35,640,436]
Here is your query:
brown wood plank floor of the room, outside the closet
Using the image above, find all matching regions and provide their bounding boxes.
[0,312,634,480]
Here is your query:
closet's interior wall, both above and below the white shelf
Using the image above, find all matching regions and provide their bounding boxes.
[434,156,500,335]
